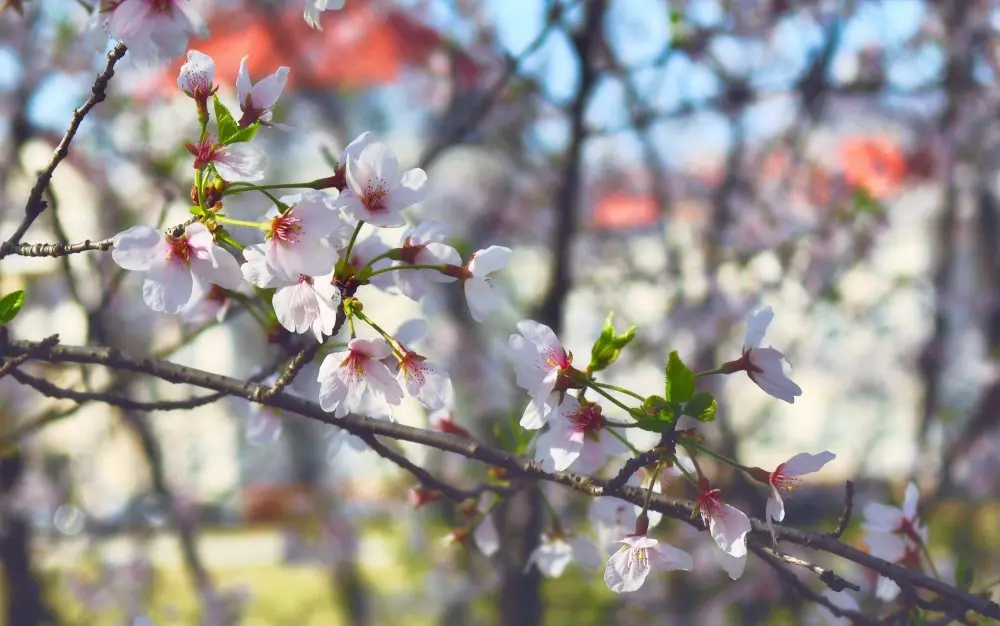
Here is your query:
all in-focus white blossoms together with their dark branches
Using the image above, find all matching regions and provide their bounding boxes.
[0,0,1000,625]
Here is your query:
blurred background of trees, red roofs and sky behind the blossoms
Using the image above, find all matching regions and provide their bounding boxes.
[0,0,1000,626]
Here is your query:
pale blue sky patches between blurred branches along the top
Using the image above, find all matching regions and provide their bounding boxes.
[0,0,941,160]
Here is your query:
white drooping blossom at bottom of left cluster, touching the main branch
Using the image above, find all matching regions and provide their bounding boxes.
[317,338,403,417]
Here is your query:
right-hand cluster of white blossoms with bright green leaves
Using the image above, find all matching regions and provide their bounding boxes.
[500,308,834,593]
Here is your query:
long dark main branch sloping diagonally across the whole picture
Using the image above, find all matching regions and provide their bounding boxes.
[0,341,1000,619]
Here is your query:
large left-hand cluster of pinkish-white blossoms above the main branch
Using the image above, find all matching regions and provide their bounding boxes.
[112,50,511,417]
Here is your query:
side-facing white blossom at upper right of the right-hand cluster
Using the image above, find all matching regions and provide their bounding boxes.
[722,306,802,404]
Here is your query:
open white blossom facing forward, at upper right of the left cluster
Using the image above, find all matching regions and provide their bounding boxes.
[341,143,427,227]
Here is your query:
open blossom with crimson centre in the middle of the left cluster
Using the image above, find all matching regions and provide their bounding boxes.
[264,191,342,276]
